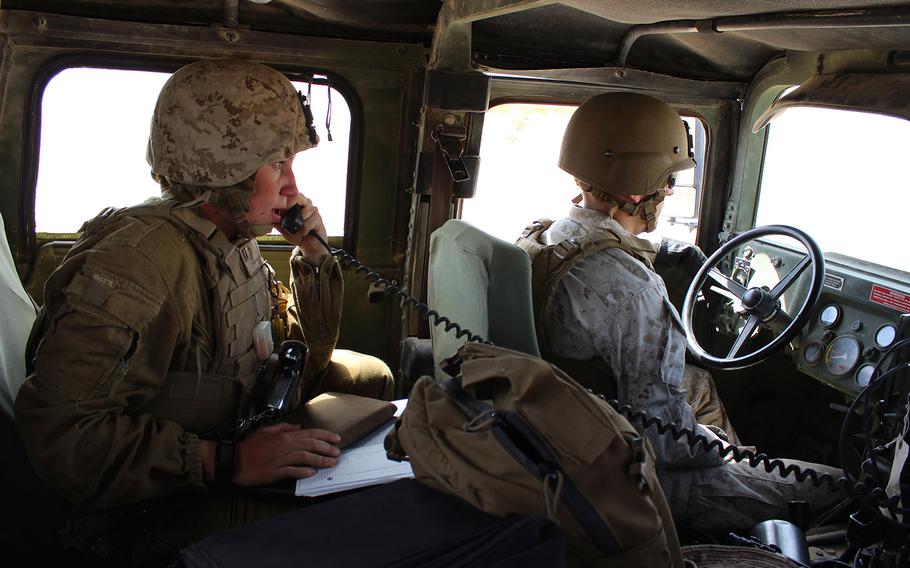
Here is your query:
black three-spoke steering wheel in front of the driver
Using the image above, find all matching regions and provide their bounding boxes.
[682,225,825,369]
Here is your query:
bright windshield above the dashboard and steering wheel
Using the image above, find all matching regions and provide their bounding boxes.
[755,107,910,272]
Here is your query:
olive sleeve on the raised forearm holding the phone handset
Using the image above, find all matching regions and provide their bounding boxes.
[288,248,344,377]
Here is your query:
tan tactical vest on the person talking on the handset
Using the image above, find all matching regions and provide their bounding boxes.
[75,200,271,434]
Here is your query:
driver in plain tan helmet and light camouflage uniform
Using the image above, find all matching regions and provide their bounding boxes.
[518,93,838,532]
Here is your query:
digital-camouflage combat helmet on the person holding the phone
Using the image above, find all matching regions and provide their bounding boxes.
[146,59,319,237]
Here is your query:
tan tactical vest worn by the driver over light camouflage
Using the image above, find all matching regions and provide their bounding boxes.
[515,219,654,397]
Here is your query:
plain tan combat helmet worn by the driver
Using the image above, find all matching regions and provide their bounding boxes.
[559,93,695,231]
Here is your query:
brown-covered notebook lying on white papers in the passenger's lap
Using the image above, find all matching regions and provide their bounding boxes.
[284,392,396,448]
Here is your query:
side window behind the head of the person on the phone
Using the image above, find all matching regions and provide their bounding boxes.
[35,67,351,236]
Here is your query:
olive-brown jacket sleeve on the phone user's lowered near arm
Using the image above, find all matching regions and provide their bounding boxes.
[16,249,203,508]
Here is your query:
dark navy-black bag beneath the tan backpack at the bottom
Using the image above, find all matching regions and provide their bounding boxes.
[180,479,565,568]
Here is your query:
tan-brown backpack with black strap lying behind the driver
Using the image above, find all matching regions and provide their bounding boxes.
[387,343,682,566]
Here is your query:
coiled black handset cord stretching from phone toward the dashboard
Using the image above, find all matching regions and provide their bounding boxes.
[309,231,899,508]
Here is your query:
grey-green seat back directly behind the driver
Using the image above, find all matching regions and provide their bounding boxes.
[427,219,540,380]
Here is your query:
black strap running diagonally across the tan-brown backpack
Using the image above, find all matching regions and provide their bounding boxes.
[441,377,622,556]
